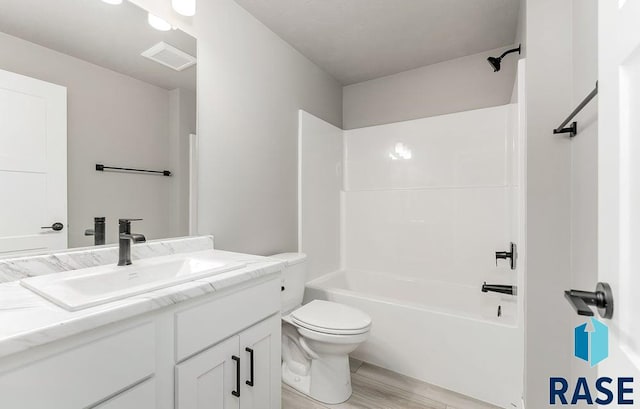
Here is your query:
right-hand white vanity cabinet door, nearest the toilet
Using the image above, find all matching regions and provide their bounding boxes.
[240,314,282,409]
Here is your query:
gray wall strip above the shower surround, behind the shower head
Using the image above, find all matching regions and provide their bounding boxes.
[343,47,517,129]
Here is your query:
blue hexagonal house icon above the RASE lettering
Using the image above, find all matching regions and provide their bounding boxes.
[573,318,609,367]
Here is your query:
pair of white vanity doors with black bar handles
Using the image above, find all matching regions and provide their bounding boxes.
[176,315,281,409]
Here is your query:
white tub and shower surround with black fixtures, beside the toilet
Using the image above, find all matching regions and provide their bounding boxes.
[299,71,526,408]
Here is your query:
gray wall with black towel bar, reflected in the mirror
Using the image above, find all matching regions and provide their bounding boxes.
[0,34,185,247]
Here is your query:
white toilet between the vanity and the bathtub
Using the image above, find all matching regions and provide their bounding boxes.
[271,253,371,404]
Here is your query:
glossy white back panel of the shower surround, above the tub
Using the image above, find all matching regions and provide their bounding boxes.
[344,105,517,291]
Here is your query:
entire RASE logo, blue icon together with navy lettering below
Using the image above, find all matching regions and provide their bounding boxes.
[549,318,634,405]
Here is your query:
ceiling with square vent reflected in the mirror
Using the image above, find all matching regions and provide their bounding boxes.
[0,0,196,91]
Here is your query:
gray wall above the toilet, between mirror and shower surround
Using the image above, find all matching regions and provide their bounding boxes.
[135,0,342,255]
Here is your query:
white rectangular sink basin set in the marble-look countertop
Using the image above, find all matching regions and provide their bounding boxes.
[20,252,245,311]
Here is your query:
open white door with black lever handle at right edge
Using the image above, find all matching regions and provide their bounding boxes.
[598,0,640,396]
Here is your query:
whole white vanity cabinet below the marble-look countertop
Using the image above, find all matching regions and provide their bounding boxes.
[0,274,281,409]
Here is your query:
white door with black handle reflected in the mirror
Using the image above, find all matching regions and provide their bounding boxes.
[0,70,67,256]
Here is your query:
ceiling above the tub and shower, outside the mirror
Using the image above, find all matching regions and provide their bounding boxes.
[236,0,520,85]
